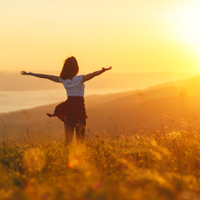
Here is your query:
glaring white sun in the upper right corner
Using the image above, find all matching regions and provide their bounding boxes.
[170,0,200,59]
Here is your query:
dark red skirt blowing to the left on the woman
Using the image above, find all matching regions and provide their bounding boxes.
[47,96,87,126]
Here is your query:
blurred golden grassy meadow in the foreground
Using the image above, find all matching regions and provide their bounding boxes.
[0,116,200,200]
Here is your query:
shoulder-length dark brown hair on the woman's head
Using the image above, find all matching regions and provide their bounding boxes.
[60,56,79,80]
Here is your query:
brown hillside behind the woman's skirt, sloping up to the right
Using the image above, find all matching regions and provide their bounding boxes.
[0,76,200,141]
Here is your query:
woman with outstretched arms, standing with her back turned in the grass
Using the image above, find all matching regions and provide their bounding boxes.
[21,56,112,144]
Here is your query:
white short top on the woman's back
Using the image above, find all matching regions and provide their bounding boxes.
[59,75,85,97]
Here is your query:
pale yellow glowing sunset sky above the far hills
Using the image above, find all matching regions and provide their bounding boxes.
[0,0,200,74]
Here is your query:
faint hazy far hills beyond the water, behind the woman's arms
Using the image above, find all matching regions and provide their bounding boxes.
[0,71,194,91]
